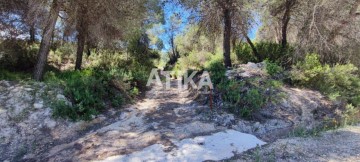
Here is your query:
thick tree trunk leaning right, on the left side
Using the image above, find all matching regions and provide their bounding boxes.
[34,0,60,81]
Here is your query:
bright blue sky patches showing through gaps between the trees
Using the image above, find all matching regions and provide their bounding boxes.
[157,2,260,51]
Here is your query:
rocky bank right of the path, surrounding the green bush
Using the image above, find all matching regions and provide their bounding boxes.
[217,62,341,142]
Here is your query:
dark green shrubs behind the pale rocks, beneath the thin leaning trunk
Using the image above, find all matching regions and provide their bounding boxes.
[235,42,294,66]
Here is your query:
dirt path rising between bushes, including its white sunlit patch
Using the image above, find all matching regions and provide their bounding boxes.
[41,81,265,161]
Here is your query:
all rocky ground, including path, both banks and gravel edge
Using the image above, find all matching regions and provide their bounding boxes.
[0,63,359,161]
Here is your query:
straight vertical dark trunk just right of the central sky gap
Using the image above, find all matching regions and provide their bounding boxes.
[224,9,232,68]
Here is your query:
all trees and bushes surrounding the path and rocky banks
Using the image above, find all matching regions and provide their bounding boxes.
[0,0,360,123]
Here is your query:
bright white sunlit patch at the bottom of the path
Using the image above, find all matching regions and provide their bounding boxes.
[97,130,266,162]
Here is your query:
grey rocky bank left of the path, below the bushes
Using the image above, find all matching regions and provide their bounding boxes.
[0,81,112,161]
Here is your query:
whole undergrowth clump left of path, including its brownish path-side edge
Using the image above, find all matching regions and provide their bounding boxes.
[45,69,145,121]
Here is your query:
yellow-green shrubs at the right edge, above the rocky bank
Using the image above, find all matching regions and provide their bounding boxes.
[291,54,360,106]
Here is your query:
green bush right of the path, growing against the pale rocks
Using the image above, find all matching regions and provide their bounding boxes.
[206,58,282,119]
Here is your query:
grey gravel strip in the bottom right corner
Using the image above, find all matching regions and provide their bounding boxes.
[231,125,360,162]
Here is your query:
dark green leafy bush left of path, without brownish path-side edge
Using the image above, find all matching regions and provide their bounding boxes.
[45,69,125,120]
